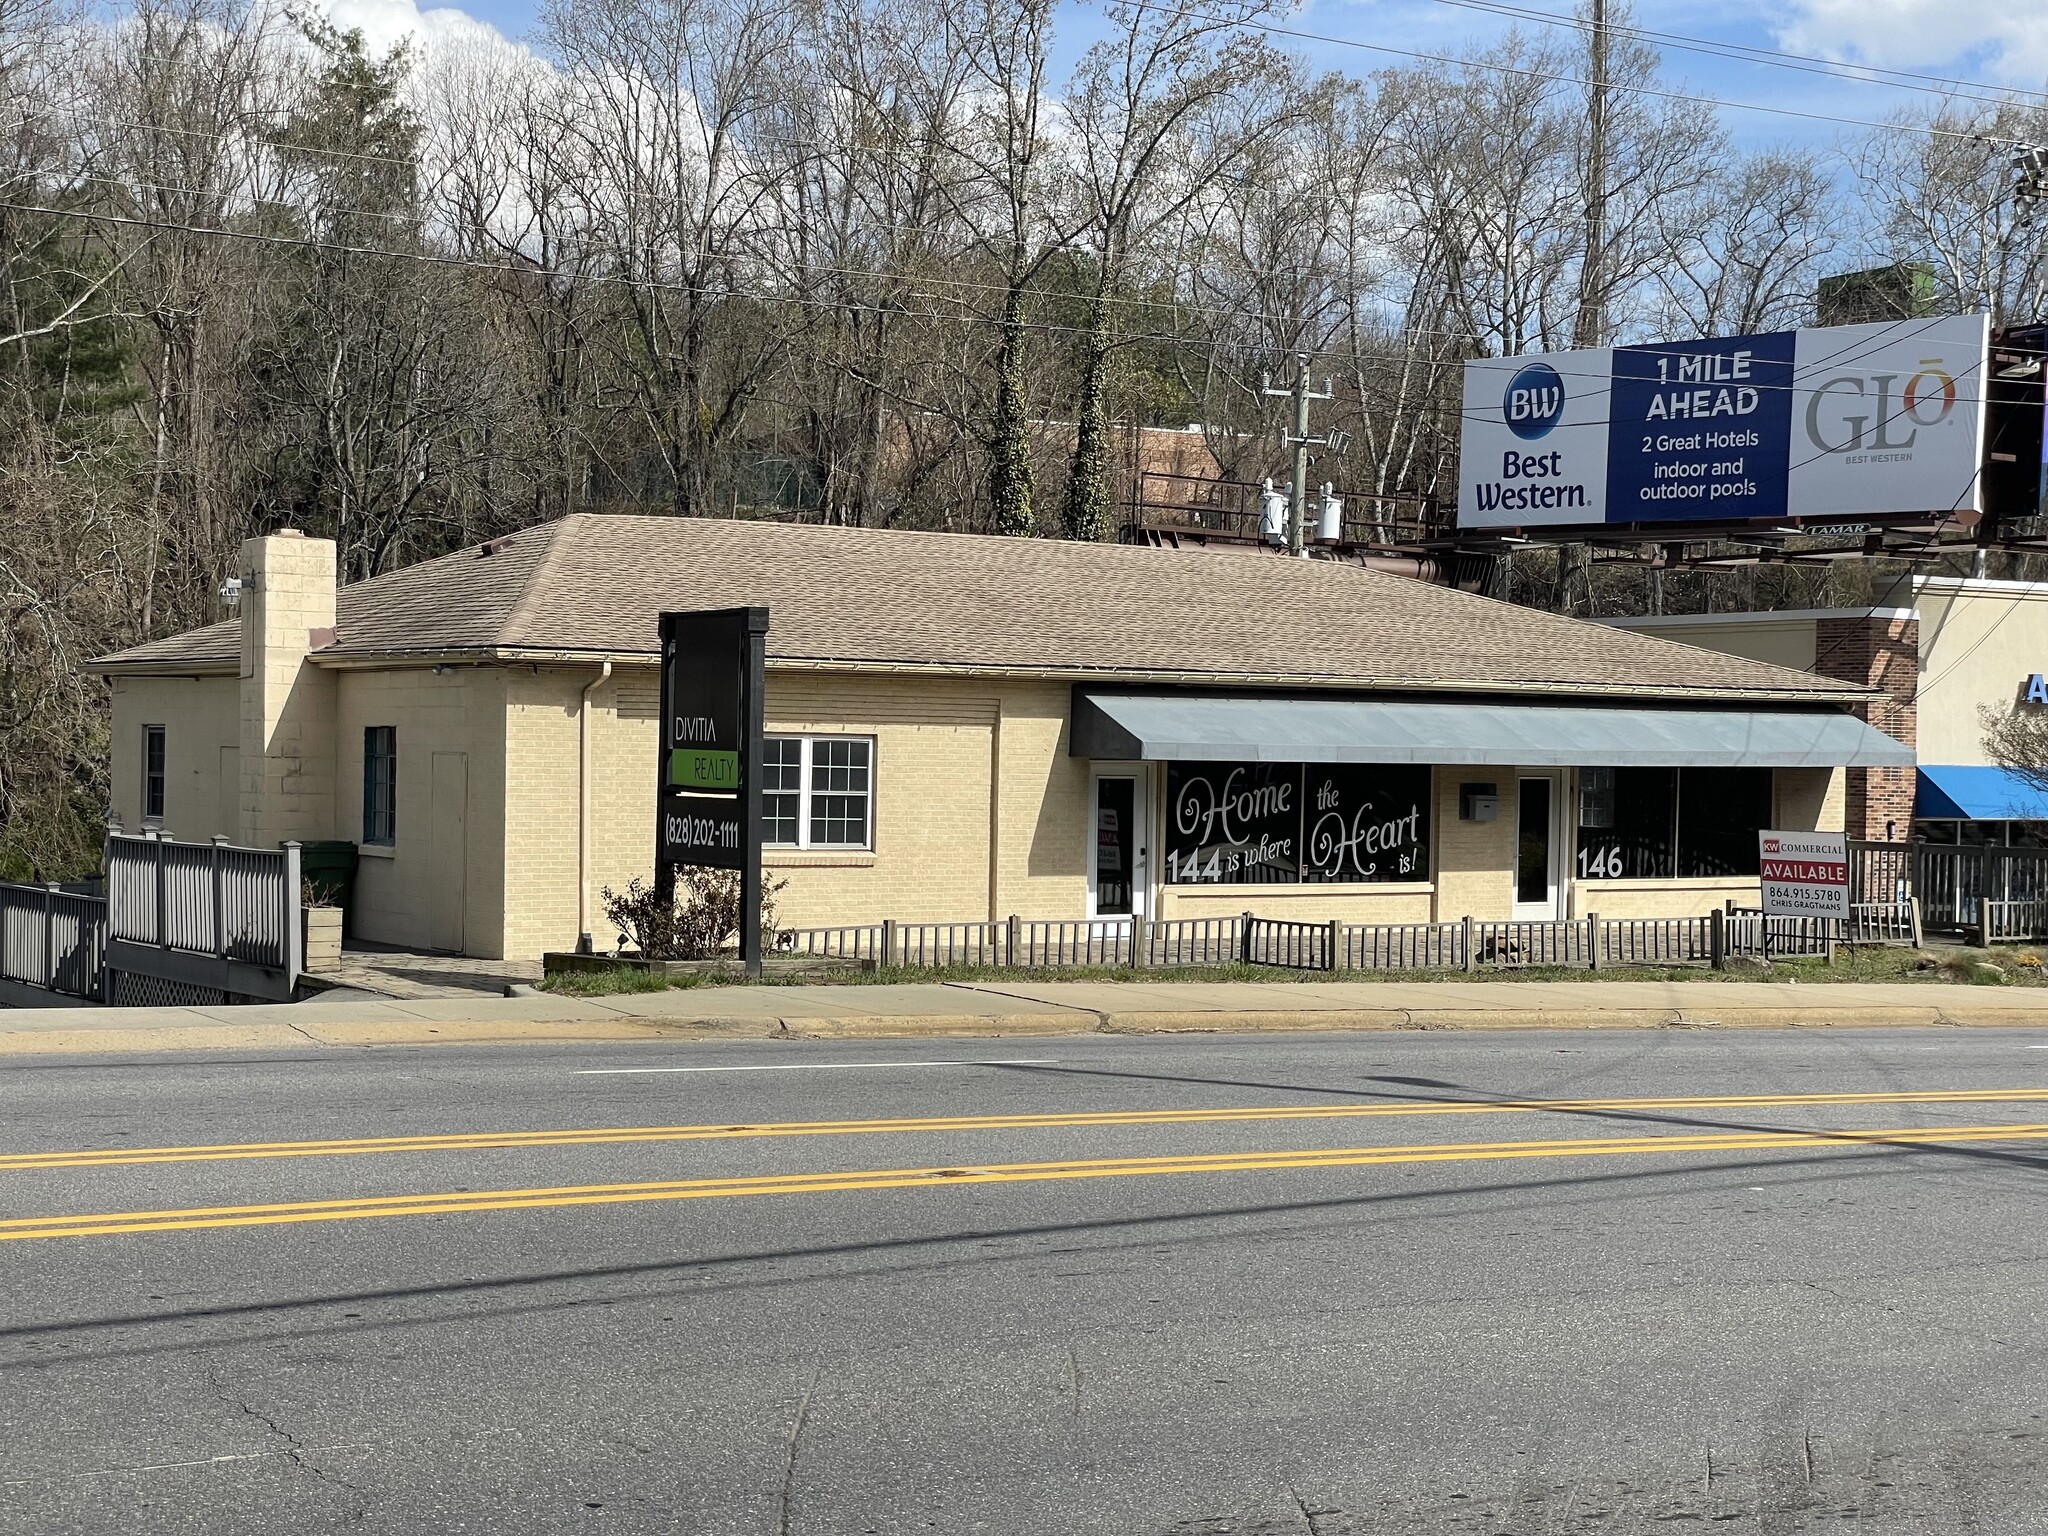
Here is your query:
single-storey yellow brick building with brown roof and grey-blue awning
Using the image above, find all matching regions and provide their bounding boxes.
[92,516,1911,956]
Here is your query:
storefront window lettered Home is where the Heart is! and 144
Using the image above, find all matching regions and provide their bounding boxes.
[1165,762,1430,885]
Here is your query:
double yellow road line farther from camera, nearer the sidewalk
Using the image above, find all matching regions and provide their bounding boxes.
[0,1087,2048,1174]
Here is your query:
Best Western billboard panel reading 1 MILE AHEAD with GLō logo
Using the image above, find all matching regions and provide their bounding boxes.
[1458,315,1991,528]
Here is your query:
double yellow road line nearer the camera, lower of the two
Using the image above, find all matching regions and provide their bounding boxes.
[0,1124,2048,1241]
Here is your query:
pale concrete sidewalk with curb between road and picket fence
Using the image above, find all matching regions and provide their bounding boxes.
[0,981,2048,1055]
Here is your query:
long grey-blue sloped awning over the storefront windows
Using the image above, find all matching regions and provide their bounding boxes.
[1071,692,1913,768]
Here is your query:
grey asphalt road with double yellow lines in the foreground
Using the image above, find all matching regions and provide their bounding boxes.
[0,1030,2048,1536]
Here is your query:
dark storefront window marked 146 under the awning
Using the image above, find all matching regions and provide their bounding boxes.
[1575,768,1772,881]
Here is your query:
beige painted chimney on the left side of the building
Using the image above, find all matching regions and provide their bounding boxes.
[240,528,336,848]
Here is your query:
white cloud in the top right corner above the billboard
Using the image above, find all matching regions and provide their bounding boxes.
[1778,0,2048,90]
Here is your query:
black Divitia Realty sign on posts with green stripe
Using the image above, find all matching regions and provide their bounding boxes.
[655,608,768,973]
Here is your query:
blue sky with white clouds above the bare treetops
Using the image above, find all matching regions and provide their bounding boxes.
[326,0,2048,157]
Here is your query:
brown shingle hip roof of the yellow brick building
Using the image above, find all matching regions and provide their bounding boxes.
[83,514,1864,700]
